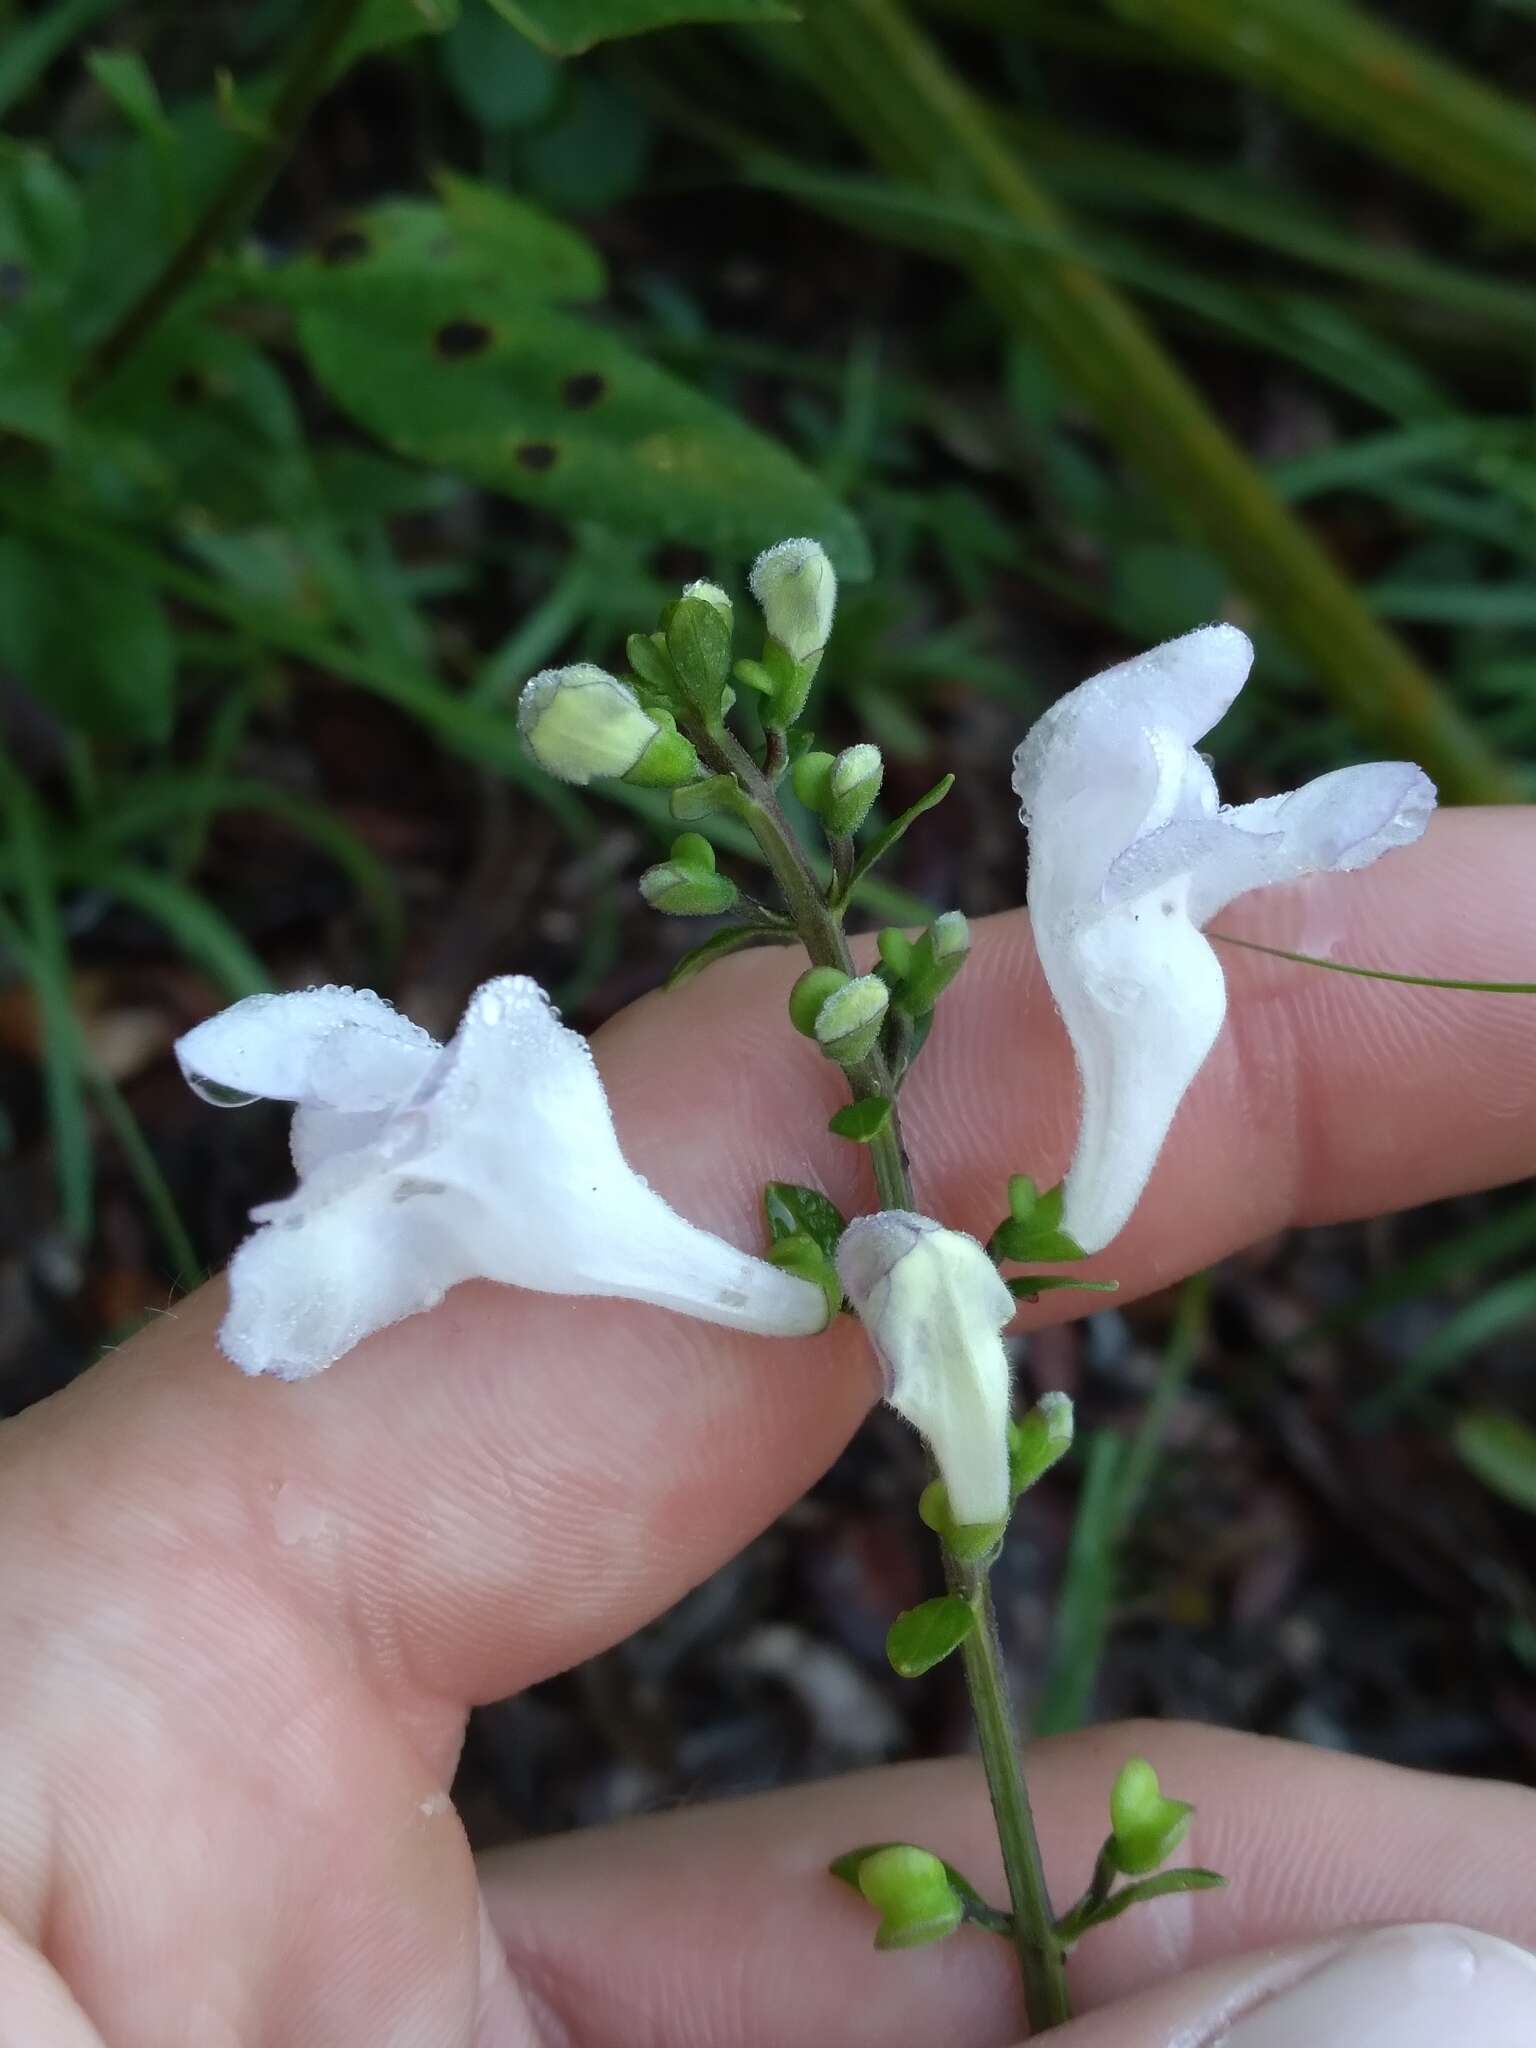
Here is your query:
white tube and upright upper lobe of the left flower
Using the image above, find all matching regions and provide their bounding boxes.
[410,975,827,1335]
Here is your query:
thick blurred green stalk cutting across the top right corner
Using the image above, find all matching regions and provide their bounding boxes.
[1108,0,1536,236]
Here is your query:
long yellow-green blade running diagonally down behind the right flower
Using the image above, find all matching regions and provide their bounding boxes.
[772,0,1516,801]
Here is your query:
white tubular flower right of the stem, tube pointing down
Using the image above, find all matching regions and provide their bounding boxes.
[1014,625,1436,1251]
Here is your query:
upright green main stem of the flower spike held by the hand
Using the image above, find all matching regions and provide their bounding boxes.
[716,725,1071,2034]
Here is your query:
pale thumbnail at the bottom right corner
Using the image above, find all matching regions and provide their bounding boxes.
[1210,1927,1536,2048]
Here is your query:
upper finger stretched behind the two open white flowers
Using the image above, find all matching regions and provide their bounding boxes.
[16,811,1536,1704]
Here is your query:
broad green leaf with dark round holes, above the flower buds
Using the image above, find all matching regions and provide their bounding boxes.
[299,279,868,578]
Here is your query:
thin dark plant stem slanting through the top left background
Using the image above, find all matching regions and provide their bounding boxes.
[76,0,367,395]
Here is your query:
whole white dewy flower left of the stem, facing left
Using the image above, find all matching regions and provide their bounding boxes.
[176,975,825,1380]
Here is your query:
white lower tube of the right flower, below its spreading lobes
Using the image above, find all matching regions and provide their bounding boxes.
[1036,899,1227,1251]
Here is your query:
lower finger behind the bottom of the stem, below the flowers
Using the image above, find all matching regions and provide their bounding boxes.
[483,1724,1536,2048]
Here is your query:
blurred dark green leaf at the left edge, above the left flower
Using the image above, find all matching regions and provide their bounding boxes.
[0,539,176,739]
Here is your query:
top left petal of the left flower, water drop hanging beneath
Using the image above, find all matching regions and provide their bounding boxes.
[176,987,438,1110]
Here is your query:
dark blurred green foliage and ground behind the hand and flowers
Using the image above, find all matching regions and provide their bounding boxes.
[0,0,1536,1831]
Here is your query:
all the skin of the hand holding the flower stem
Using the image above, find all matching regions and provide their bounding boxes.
[0,811,1536,2048]
